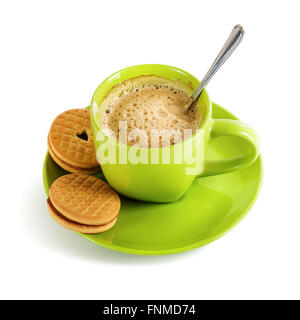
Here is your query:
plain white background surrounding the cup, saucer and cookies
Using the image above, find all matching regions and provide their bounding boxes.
[0,0,300,299]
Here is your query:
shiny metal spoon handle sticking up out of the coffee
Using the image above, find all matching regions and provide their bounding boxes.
[184,24,245,112]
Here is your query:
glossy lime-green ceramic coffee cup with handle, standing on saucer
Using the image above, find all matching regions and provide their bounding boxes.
[90,64,260,202]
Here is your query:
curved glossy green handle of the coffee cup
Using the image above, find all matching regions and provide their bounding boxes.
[201,119,260,176]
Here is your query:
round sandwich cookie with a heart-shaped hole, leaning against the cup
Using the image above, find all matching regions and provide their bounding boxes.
[48,109,101,174]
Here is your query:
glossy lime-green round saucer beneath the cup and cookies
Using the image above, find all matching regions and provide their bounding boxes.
[43,104,263,255]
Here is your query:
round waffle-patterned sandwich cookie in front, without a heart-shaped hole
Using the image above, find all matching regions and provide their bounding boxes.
[47,174,121,233]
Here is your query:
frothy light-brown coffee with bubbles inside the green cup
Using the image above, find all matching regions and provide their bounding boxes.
[100,76,202,148]
